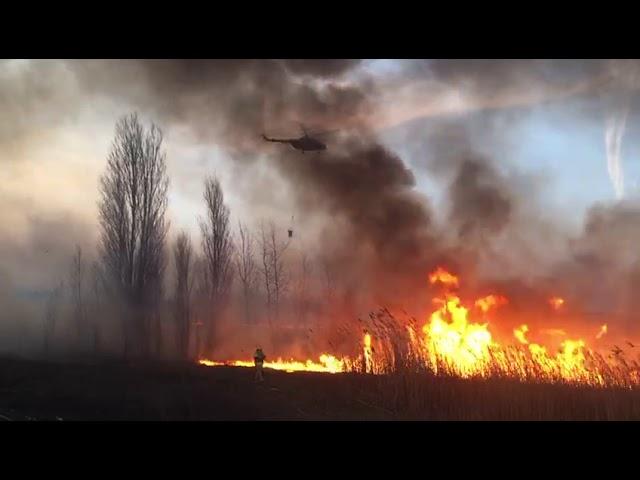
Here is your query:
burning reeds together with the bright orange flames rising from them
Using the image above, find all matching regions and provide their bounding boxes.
[200,268,640,389]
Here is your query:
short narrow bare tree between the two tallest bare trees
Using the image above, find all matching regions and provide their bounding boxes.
[173,231,193,360]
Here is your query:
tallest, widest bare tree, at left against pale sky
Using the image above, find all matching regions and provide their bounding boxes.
[99,114,169,354]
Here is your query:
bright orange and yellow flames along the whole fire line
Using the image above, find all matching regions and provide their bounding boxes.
[200,268,640,387]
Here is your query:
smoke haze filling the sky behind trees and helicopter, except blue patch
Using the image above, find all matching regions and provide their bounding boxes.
[0,60,640,356]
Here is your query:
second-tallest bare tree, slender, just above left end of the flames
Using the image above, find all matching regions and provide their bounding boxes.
[200,176,233,350]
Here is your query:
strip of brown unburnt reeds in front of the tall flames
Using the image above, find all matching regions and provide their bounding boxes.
[353,372,640,420]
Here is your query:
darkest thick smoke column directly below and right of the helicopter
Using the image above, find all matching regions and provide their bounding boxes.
[277,137,444,302]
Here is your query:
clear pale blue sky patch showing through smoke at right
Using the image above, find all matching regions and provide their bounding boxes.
[367,60,640,223]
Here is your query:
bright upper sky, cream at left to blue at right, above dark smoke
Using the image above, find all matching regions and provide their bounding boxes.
[0,60,640,295]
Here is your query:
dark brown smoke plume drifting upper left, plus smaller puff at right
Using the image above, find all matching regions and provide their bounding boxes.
[61,60,616,316]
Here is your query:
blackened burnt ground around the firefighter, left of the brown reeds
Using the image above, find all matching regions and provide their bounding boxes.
[0,358,383,421]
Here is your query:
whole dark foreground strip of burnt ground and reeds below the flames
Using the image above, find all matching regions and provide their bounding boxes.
[0,358,640,421]
